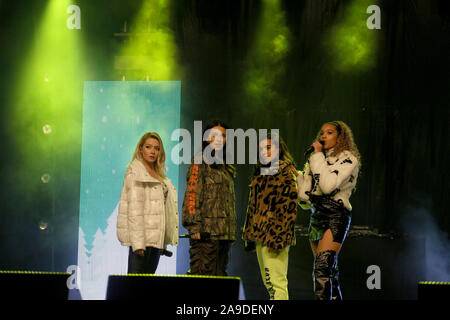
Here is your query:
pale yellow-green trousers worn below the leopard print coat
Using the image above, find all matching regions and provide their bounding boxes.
[256,242,289,300]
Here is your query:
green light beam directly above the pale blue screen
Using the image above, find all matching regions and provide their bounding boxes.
[115,0,180,81]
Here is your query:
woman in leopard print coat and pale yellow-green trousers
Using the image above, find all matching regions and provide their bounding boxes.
[243,134,298,300]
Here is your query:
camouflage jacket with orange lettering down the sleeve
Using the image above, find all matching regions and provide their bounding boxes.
[182,154,236,241]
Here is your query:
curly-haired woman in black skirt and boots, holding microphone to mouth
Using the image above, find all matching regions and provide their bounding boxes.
[297,121,361,300]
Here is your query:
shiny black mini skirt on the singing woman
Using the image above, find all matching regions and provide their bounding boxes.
[308,194,352,243]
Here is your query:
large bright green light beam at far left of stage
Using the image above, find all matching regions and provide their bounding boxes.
[8,0,86,181]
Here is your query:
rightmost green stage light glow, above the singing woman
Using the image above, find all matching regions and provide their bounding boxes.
[326,0,379,72]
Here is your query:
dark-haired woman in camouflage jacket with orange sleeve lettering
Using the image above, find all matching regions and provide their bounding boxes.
[182,120,236,276]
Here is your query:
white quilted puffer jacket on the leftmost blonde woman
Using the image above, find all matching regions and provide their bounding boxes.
[117,159,178,251]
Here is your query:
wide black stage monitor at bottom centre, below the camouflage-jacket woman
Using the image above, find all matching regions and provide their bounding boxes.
[106,274,240,302]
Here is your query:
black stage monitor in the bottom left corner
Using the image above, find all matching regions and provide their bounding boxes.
[0,271,70,300]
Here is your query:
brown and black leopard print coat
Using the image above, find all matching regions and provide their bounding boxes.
[242,160,297,250]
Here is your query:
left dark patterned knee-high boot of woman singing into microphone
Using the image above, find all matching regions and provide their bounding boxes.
[314,250,336,300]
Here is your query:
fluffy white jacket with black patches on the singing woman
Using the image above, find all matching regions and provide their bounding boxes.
[297,149,359,210]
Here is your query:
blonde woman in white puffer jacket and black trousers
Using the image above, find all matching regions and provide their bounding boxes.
[117,132,178,273]
